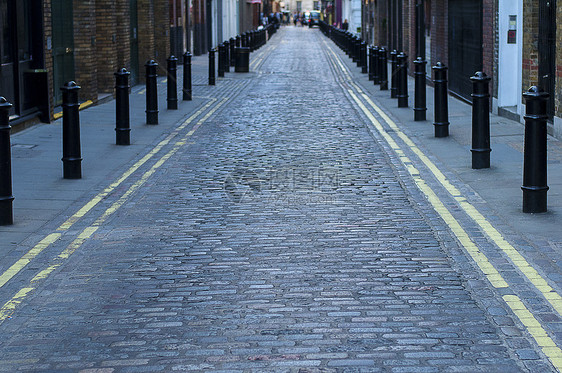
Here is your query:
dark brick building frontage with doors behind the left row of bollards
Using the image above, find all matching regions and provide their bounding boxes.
[0,0,170,131]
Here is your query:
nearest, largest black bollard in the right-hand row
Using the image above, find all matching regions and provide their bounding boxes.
[521,86,550,213]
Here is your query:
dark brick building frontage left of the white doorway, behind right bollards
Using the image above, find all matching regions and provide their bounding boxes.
[363,0,497,100]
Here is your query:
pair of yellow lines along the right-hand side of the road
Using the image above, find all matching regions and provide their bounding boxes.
[324,43,562,371]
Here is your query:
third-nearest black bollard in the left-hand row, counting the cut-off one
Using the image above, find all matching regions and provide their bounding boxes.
[114,68,131,145]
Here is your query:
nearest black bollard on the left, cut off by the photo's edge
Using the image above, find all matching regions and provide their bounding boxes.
[0,97,14,225]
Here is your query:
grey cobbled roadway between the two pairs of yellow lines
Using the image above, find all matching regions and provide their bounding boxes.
[0,27,538,373]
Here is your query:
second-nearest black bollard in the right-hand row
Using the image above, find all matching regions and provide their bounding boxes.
[470,71,492,169]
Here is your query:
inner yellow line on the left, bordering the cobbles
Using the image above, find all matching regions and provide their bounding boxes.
[0,98,228,324]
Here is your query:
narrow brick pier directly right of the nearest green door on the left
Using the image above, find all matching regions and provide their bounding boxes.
[73,0,98,102]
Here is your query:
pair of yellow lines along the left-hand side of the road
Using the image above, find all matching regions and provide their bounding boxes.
[0,89,232,324]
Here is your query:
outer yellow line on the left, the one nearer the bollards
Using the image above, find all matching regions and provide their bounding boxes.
[0,99,222,288]
